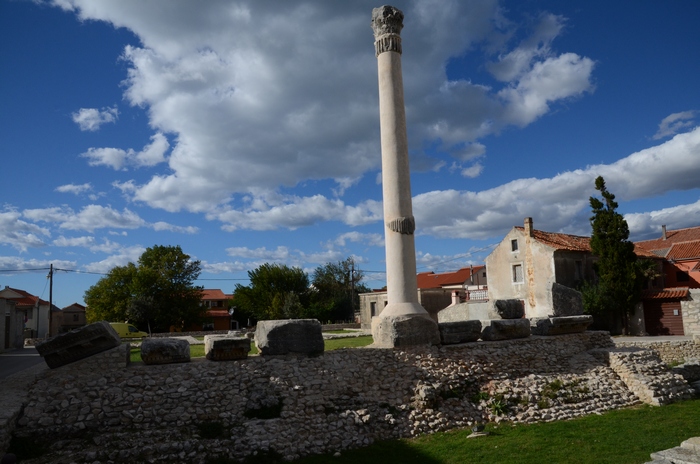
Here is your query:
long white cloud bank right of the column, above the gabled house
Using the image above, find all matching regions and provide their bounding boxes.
[413,128,700,239]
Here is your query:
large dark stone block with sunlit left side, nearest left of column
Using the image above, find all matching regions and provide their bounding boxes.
[255,319,324,356]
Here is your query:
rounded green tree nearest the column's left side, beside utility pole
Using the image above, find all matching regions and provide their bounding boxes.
[312,258,369,321]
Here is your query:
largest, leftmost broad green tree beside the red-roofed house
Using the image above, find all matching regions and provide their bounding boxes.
[85,245,204,331]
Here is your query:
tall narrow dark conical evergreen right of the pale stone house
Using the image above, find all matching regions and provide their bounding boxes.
[584,176,641,334]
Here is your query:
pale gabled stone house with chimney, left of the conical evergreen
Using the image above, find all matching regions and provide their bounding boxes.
[486,218,595,318]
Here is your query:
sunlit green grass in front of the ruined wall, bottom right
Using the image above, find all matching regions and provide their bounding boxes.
[294,399,700,464]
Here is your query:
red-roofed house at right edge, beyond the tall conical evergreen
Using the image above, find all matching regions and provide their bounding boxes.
[635,226,700,335]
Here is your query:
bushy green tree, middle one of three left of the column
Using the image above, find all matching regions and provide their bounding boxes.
[233,263,311,320]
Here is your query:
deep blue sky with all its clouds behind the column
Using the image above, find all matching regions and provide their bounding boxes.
[0,0,700,306]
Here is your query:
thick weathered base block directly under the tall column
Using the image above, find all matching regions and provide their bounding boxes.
[372,315,440,348]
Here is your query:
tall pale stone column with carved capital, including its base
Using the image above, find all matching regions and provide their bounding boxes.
[372,5,440,347]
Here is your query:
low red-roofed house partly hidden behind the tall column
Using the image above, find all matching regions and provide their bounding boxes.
[360,265,487,329]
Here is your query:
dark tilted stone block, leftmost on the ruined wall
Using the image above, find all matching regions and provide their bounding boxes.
[36,321,121,369]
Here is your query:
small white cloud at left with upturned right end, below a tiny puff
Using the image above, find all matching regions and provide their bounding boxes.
[80,133,170,171]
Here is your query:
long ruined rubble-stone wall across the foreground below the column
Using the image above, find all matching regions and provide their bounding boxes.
[10,332,700,462]
